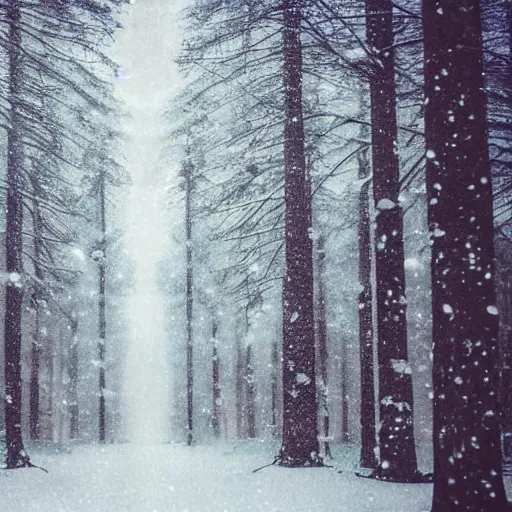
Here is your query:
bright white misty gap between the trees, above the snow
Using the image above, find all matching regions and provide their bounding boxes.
[114,0,186,442]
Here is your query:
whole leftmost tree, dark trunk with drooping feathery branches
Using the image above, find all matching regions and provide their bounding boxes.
[0,0,125,460]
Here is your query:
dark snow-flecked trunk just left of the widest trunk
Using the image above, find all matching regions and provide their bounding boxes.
[365,0,418,482]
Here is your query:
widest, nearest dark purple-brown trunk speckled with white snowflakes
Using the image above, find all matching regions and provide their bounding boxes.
[423,0,507,512]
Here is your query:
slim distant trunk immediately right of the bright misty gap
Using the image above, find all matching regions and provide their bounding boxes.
[183,155,194,446]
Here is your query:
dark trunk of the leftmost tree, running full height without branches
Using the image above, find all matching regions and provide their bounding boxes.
[4,0,30,469]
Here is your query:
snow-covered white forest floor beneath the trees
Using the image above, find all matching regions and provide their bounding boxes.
[0,442,512,512]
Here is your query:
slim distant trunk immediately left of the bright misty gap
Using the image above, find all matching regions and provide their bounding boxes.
[98,171,107,443]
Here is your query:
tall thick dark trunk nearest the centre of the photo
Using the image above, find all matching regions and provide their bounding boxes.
[278,0,322,467]
